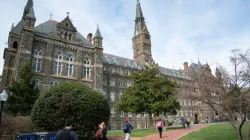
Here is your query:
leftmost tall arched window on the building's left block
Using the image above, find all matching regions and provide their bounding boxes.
[32,49,42,72]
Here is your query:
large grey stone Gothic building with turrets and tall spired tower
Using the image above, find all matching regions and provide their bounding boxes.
[1,0,216,129]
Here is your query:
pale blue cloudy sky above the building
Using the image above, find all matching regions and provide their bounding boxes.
[0,0,250,72]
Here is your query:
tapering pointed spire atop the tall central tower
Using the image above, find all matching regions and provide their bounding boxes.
[134,0,145,36]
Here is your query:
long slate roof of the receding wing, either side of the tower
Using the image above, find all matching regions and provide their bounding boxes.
[102,53,189,79]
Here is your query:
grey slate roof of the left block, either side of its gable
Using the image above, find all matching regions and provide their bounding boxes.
[35,20,92,46]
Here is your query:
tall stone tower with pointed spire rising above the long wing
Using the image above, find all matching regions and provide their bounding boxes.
[132,0,154,64]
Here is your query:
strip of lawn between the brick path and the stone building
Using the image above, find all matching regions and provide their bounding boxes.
[107,127,181,138]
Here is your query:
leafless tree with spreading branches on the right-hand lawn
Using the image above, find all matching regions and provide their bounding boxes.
[189,49,250,140]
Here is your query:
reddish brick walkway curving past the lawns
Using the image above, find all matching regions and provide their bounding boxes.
[108,124,209,140]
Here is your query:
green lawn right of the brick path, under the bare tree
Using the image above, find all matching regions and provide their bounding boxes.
[181,122,250,140]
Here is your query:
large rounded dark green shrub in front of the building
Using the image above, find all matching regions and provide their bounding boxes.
[31,83,110,136]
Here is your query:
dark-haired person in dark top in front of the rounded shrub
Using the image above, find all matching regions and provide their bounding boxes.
[55,118,78,140]
